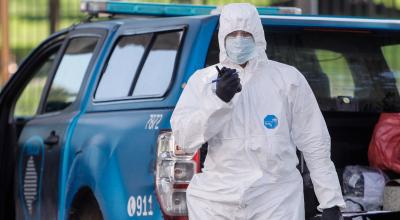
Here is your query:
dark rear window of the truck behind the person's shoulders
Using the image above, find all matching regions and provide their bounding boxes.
[206,27,400,112]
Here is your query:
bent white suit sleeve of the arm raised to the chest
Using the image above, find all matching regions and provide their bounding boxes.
[171,72,233,153]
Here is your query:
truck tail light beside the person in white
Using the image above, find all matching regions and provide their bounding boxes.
[156,131,199,219]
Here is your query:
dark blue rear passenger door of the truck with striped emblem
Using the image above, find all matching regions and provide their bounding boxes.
[14,29,105,219]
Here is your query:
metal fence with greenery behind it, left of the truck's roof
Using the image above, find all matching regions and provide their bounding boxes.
[0,0,83,87]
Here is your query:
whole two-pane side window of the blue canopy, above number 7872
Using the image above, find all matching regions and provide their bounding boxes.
[95,30,183,100]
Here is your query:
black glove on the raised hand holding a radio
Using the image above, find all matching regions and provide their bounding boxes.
[215,66,242,102]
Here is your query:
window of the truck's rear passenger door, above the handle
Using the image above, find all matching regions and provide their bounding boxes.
[44,37,98,112]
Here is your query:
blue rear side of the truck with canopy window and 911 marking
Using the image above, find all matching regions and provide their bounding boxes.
[67,17,217,219]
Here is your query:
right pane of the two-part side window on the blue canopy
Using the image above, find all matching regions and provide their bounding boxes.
[133,31,182,97]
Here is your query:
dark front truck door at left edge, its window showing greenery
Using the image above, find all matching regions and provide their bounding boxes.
[0,31,67,219]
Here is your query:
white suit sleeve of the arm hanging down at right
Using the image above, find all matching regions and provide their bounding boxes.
[291,70,345,210]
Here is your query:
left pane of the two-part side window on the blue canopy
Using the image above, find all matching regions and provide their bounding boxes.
[95,34,152,99]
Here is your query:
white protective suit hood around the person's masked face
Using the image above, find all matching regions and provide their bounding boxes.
[218,3,267,63]
